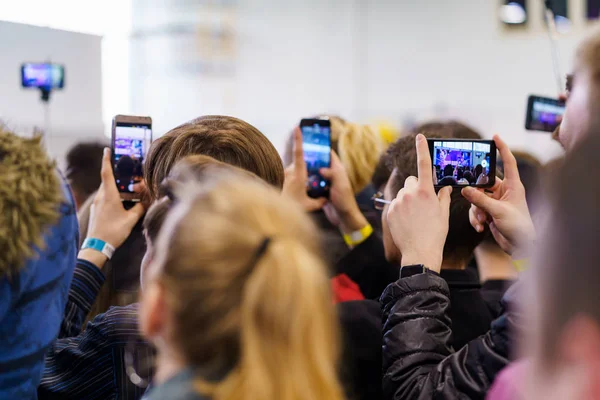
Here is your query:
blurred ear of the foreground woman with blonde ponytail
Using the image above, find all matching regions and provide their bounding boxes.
[139,282,167,341]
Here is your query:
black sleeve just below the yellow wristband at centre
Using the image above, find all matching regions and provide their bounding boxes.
[336,232,399,300]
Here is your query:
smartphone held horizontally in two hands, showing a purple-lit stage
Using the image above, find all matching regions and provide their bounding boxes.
[427,139,496,188]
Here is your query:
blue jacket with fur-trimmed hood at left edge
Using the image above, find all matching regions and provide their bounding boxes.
[0,177,79,400]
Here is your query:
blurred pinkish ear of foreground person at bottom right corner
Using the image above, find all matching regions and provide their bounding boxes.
[558,315,600,399]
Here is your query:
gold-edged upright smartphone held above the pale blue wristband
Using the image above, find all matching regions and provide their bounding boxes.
[111,115,152,201]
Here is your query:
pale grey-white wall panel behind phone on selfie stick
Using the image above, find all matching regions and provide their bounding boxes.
[0,21,106,163]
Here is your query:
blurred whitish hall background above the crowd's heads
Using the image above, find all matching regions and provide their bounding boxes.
[0,0,600,166]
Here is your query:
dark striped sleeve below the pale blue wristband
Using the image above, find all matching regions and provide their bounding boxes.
[58,259,104,339]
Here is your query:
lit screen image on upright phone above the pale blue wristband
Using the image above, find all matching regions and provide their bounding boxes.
[113,122,152,193]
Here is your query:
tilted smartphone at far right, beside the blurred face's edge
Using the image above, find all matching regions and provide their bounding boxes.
[525,95,565,132]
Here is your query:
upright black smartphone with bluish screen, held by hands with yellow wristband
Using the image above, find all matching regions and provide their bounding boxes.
[300,118,331,198]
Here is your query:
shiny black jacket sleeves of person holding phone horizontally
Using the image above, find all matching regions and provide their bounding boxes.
[381,273,514,400]
